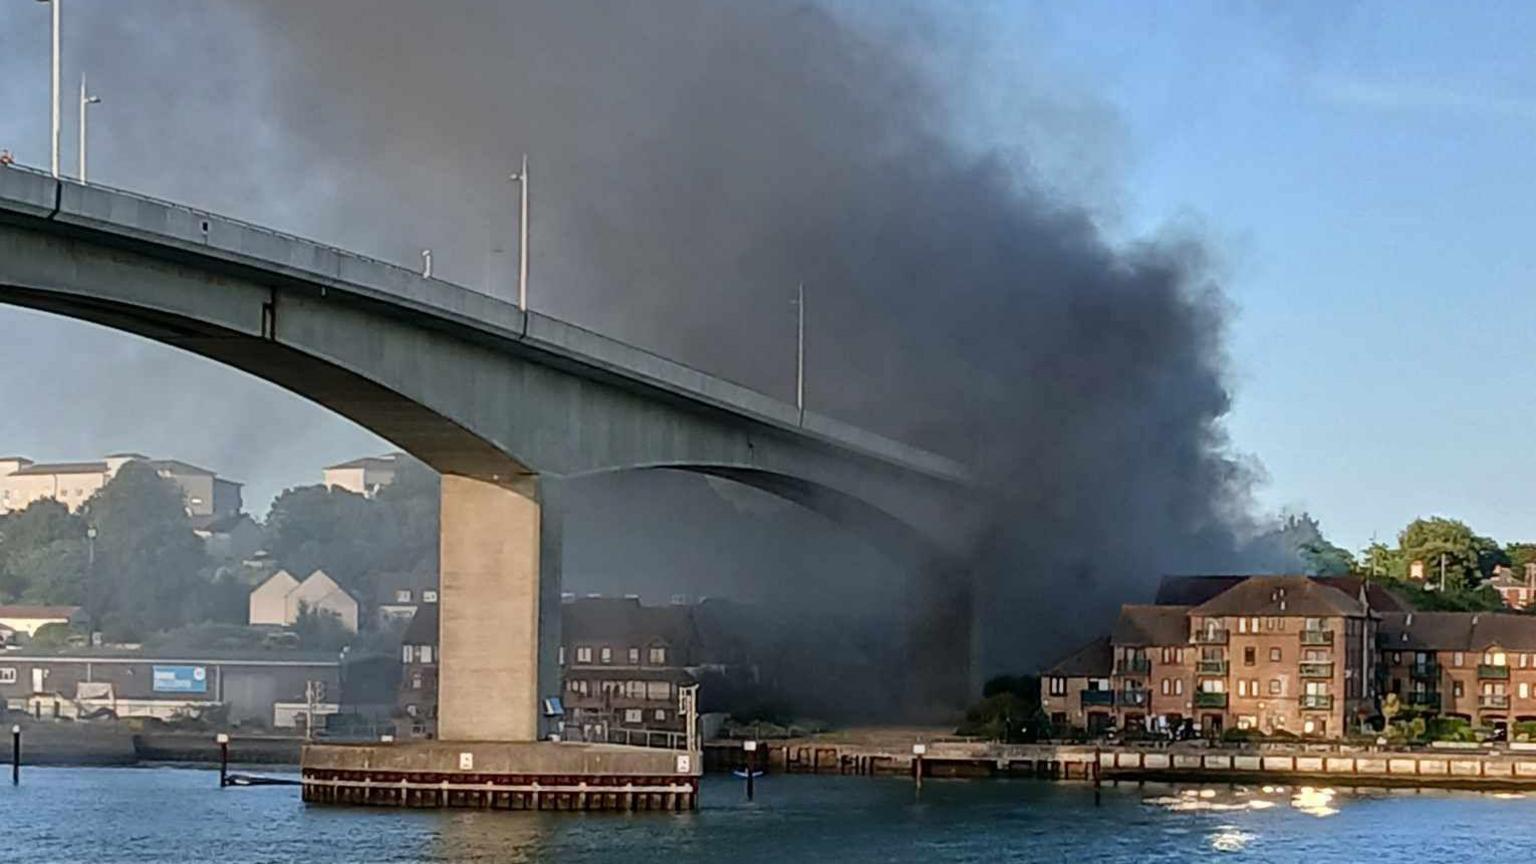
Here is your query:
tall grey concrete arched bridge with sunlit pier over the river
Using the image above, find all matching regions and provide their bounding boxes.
[0,168,971,741]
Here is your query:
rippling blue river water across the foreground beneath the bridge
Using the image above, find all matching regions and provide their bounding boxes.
[0,767,1536,864]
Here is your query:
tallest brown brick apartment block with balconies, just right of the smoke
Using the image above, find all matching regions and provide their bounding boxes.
[1041,575,1394,736]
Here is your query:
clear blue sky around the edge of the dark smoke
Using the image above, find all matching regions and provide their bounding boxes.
[12,0,1536,547]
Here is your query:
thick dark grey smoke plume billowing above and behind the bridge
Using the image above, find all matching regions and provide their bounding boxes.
[0,0,1271,685]
